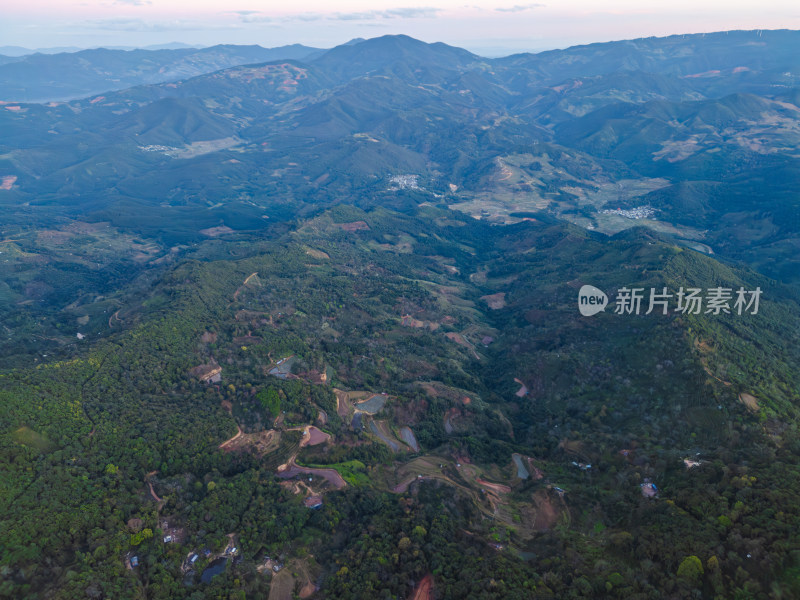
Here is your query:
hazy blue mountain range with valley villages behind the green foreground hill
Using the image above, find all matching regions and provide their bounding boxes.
[0,31,800,280]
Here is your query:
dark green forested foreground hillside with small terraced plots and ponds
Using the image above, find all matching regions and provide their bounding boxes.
[0,207,800,598]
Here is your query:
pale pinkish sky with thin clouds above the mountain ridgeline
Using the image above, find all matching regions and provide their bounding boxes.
[0,0,800,56]
